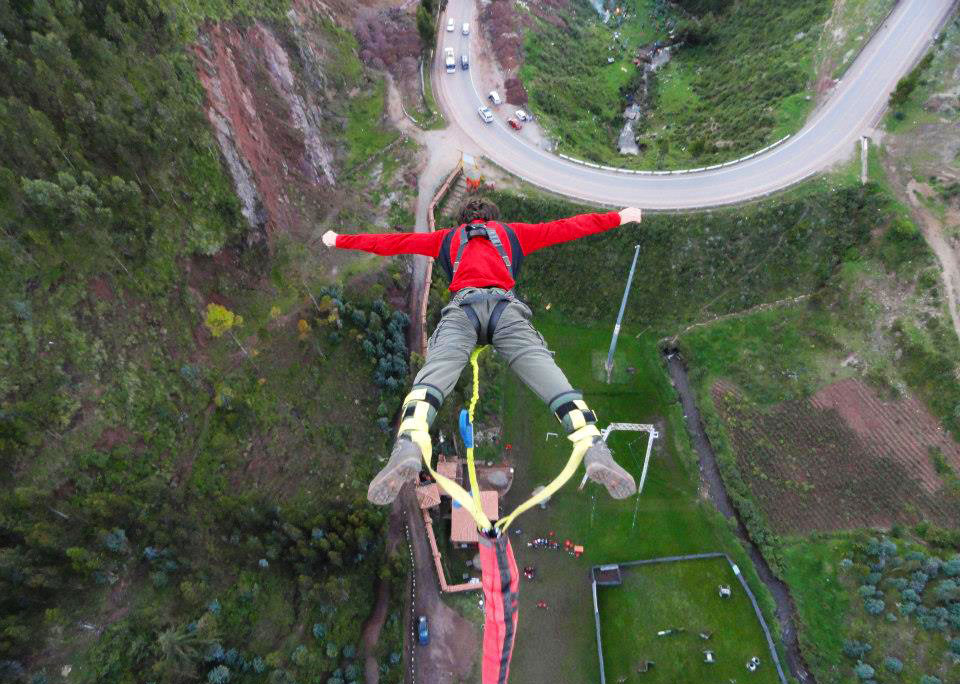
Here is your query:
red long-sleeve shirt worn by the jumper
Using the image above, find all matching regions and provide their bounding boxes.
[336,211,620,292]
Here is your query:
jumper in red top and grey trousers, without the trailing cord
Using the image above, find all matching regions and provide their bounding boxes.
[323,198,642,505]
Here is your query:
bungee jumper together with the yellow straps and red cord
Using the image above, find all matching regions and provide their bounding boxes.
[323,198,642,684]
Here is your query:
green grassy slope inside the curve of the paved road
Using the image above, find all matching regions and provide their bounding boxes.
[520,0,831,168]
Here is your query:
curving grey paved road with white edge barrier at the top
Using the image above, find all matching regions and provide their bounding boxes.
[433,0,954,209]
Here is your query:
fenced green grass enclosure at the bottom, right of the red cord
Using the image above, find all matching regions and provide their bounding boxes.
[597,558,779,684]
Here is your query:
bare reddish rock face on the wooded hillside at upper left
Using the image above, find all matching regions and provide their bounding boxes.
[193,8,336,243]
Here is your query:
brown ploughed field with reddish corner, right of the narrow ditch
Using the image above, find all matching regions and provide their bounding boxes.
[712,379,960,534]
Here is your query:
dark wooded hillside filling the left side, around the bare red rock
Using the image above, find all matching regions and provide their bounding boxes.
[0,1,406,683]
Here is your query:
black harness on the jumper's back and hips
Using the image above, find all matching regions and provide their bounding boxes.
[437,223,523,344]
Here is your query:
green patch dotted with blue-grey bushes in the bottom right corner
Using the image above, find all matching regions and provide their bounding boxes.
[784,526,960,684]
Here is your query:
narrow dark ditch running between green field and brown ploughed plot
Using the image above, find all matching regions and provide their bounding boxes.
[667,353,816,684]
